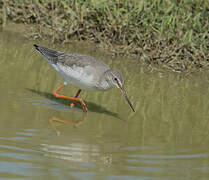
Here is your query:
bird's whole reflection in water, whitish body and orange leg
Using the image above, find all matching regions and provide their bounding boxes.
[41,113,112,165]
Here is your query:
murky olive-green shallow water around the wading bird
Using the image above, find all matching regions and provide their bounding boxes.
[0,32,209,180]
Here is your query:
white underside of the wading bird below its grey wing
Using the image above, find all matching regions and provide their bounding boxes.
[51,64,98,90]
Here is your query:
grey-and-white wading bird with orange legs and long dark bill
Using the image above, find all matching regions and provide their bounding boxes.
[34,44,134,112]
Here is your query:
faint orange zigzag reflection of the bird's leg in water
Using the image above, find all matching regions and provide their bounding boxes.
[49,114,87,135]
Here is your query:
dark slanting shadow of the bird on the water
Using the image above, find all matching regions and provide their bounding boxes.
[26,88,120,119]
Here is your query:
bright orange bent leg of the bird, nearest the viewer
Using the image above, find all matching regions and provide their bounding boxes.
[53,84,88,112]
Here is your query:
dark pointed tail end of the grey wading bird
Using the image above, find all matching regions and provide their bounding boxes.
[34,44,63,64]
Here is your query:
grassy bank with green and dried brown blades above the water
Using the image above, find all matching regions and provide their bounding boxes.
[0,0,209,72]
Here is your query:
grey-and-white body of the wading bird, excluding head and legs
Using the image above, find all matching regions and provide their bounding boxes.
[34,45,110,90]
